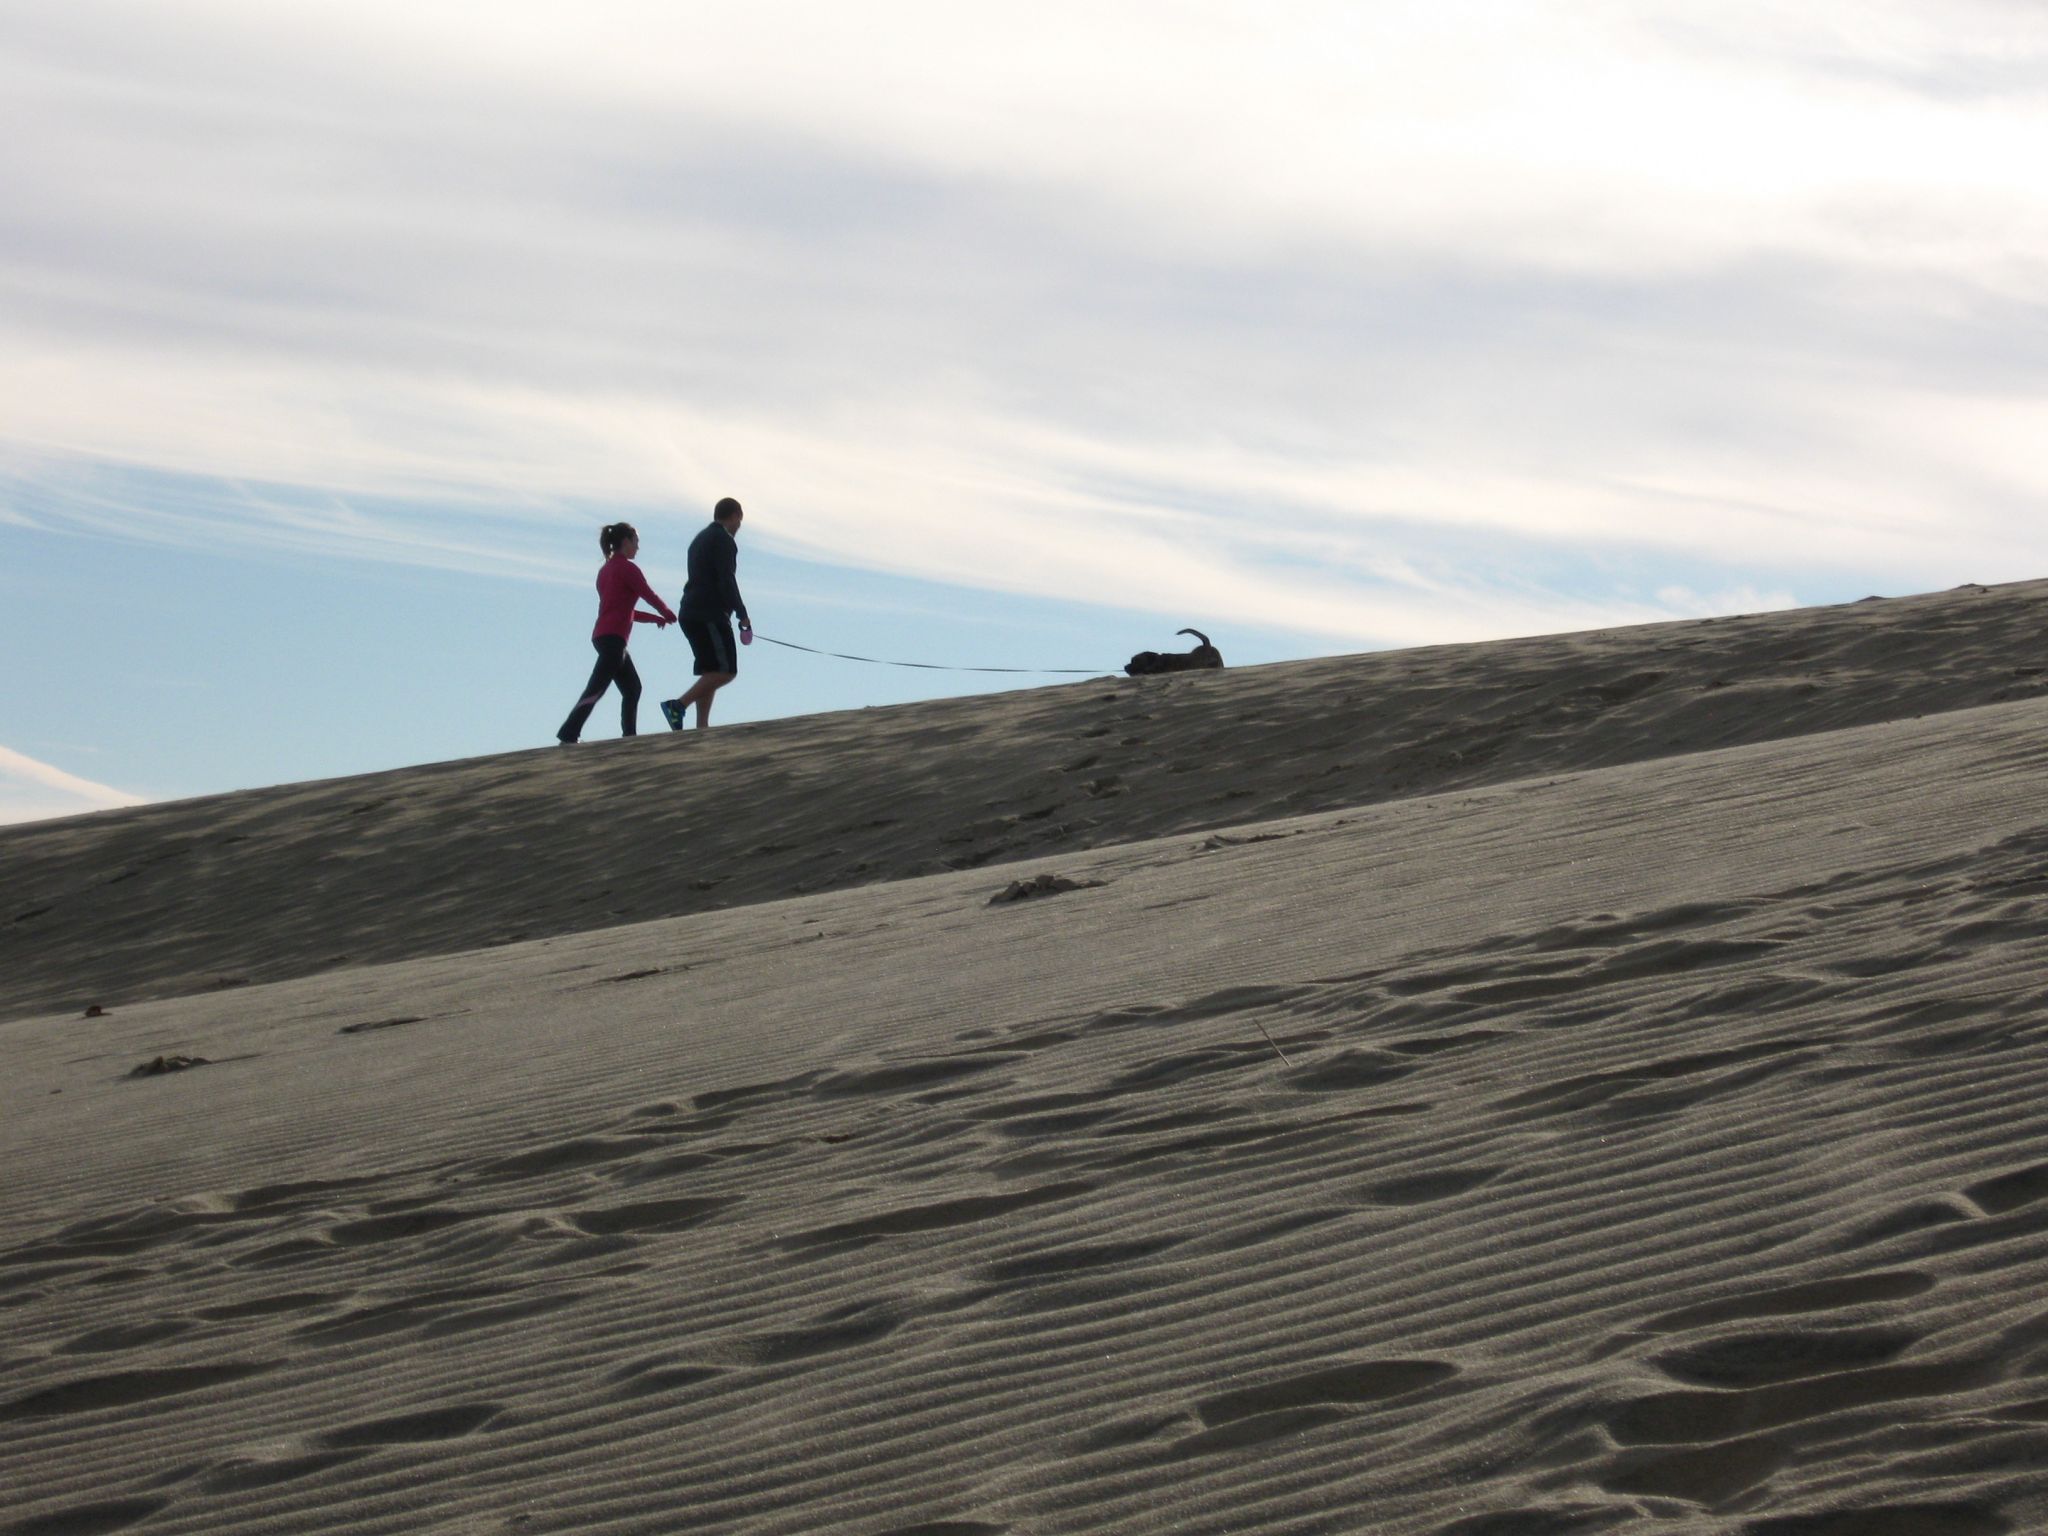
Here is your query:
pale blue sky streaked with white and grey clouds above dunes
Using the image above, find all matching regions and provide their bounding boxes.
[0,0,2048,821]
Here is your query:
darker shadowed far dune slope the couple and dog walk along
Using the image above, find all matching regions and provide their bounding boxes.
[0,582,2048,1020]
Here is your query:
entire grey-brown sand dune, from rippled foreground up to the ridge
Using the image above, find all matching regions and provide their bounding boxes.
[0,584,2048,1536]
